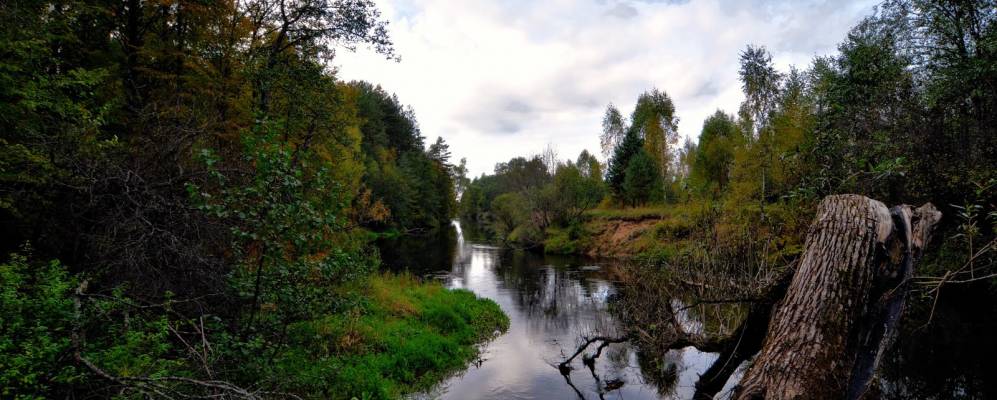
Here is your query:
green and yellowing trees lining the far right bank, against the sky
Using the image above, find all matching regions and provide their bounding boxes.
[460,0,997,264]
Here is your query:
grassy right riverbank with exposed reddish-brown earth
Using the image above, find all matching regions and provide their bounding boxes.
[543,202,810,264]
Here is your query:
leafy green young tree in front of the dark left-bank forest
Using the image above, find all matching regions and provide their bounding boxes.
[187,123,370,344]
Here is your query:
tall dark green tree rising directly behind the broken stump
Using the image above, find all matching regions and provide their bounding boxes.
[808,21,920,199]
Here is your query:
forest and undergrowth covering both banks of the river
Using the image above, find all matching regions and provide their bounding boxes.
[0,0,997,399]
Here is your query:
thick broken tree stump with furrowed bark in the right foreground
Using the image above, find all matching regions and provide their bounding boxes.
[735,195,941,399]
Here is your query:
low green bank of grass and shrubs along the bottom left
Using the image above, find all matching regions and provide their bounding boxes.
[0,255,509,399]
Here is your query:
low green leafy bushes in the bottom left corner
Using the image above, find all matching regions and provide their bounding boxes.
[0,250,202,399]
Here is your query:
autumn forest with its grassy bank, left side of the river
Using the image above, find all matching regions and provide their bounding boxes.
[0,0,508,399]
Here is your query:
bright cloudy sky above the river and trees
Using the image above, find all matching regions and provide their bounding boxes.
[334,0,876,175]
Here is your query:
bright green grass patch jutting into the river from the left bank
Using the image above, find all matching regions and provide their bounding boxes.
[274,275,509,399]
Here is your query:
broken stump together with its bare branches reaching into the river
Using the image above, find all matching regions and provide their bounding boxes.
[584,195,941,399]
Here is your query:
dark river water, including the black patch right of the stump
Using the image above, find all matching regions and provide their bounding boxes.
[379,224,997,400]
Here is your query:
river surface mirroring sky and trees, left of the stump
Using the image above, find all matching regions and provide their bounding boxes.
[381,222,716,399]
